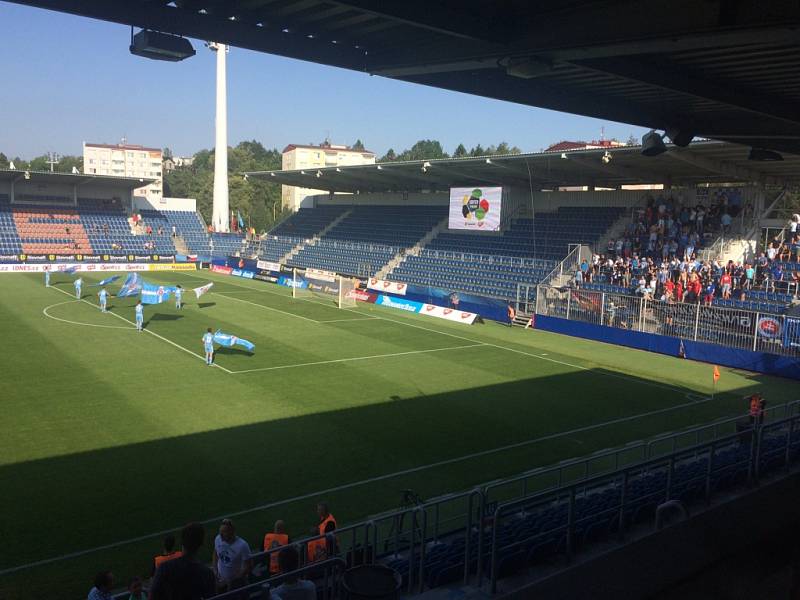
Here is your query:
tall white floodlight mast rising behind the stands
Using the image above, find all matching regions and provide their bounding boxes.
[208,42,231,233]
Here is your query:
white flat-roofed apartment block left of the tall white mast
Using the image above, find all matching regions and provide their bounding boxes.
[83,142,164,203]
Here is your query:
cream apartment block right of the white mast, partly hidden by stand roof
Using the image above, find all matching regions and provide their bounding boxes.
[281,142,375,211]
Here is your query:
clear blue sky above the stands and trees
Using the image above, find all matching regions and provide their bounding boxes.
[0,0,644,159]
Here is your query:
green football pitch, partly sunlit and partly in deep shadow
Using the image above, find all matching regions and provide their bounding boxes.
[0,272,798,600]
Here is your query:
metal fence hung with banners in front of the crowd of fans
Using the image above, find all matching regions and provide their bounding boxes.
[536,285,800,357]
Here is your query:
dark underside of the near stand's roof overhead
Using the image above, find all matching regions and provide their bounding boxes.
[13,0,800,152]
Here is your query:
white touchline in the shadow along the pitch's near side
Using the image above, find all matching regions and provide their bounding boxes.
[0,398,711,575]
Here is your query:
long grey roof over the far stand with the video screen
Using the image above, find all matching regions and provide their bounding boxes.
[247,142,800,192]
